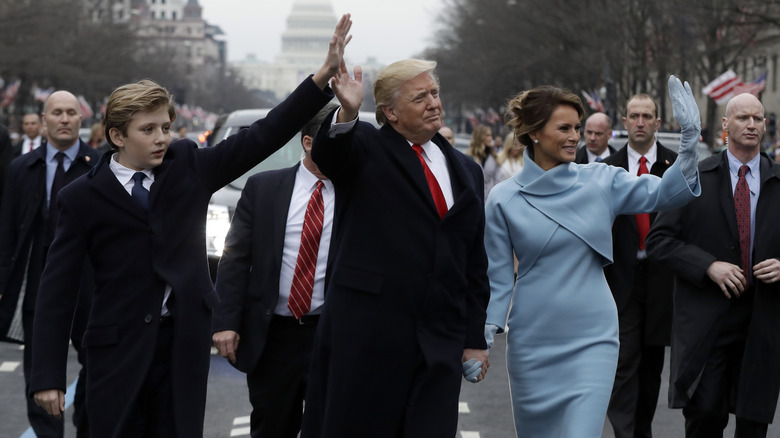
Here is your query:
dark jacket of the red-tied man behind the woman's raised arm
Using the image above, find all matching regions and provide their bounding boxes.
[604,142,677,345]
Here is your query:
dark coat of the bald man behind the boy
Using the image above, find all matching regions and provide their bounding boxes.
[0,142,100,337]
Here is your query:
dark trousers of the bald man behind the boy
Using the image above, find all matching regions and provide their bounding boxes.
[22,311,89,438]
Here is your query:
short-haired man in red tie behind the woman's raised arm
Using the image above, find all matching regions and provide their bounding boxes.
[604,94,677,438]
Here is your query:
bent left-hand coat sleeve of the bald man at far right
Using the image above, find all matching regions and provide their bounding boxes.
[647,208,717,286]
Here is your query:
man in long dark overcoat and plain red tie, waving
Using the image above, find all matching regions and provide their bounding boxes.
[301,60,489,438]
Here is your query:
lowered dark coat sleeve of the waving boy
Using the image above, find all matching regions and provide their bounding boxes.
[30,187,87,394]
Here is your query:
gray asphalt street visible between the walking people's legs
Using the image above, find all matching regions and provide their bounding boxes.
[0,336,780,438]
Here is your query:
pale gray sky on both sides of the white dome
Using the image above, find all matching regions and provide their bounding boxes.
[199,0,444,64]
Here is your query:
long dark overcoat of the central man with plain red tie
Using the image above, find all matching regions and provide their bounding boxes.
[304,117,490,436]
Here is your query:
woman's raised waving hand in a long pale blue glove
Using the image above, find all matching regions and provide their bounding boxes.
[669,75,701,184]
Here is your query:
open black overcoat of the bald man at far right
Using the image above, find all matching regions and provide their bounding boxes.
[648,151,780,423]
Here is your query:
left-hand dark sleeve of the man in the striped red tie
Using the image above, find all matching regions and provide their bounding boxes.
[212,179,258,332]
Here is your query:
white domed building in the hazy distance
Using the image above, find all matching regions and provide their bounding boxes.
[230,0,384,101]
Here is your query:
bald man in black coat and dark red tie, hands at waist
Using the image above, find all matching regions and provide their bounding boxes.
[648,90,780,438]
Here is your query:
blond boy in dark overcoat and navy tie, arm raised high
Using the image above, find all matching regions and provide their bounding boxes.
[30,15,351,438]
